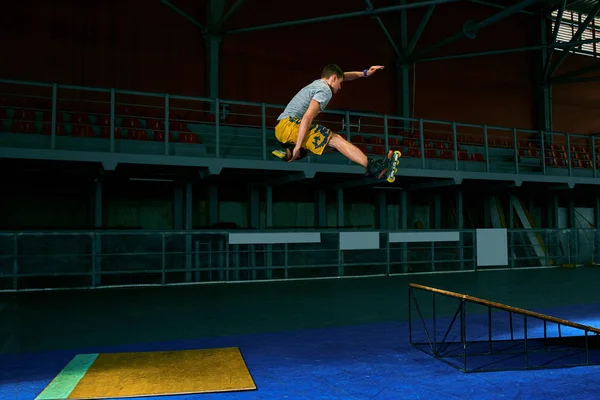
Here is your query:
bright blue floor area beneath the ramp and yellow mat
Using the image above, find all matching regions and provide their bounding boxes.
[0,304,600,400]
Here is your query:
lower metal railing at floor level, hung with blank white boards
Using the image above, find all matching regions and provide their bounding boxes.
[0,229,600,291]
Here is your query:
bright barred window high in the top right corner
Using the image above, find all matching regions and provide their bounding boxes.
[552,10,600,58]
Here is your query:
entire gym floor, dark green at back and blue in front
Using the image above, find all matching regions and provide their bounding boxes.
[0,269,600,400]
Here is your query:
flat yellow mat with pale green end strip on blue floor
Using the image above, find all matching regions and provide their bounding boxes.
[38,347,256,399]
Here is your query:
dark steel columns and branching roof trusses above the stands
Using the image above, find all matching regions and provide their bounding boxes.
[160,0,600,130]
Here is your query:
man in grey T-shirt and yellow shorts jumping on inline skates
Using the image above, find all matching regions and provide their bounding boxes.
[273,64,391,178]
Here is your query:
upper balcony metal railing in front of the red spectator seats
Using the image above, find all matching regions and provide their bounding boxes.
[0,80,600,178]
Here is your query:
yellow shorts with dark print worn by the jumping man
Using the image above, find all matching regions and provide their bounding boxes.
[275,117,333,155]
